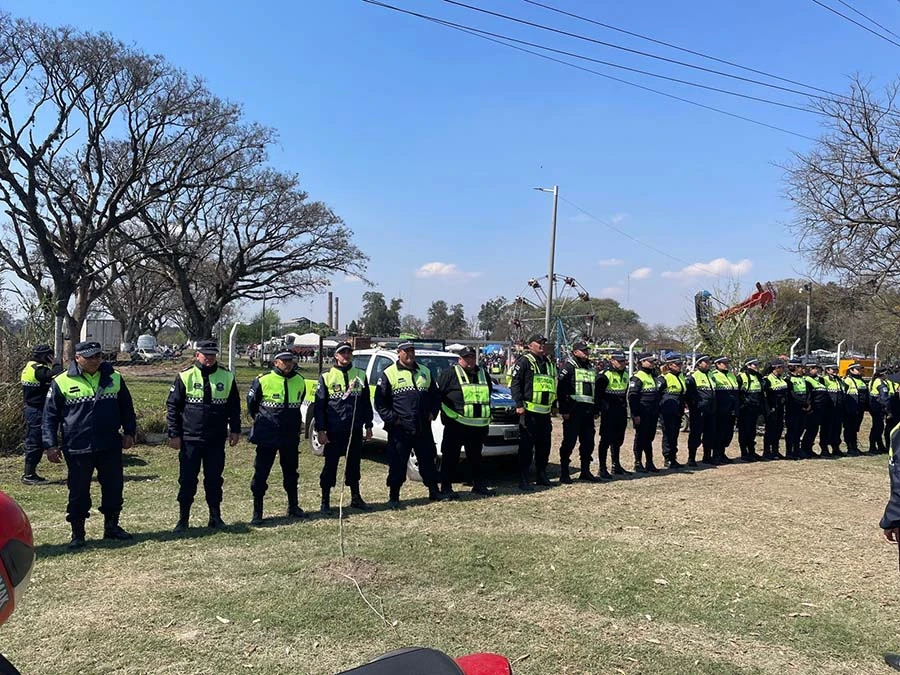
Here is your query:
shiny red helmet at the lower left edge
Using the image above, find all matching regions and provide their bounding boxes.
[0,492,34,624]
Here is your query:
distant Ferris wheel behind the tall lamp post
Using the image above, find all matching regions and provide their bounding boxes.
[509,274,594,345]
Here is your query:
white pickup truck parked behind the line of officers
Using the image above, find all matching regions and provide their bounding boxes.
[303,349,519,481]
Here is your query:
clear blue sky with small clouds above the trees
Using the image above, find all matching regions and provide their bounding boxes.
[5,0,900,332]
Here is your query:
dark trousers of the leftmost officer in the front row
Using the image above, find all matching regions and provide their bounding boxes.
[63,446,125,522]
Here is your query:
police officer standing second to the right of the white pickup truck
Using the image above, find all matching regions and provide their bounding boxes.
[557,341,599,483]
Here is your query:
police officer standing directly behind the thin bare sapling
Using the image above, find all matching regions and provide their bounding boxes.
[313,342,373,516]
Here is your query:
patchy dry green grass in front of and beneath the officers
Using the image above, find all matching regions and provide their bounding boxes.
[0,430,900,675]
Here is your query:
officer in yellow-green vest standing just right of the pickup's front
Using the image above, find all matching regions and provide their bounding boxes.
[509,335,556,492]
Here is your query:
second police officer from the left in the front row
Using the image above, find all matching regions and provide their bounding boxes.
[166,340,241,532]
